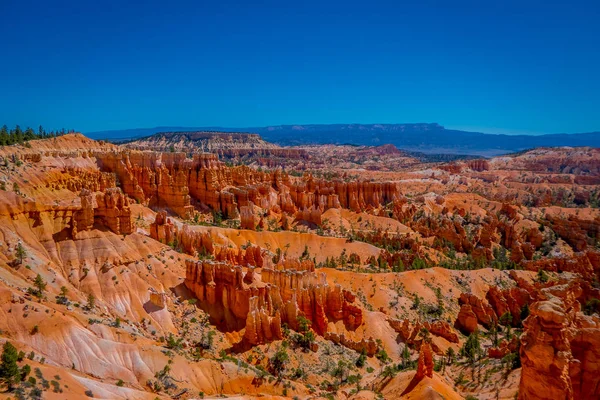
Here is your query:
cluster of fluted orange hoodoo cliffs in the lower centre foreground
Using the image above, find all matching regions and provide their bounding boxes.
[185,260,376,354]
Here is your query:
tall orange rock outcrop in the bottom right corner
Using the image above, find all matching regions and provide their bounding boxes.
[519,282,600,400]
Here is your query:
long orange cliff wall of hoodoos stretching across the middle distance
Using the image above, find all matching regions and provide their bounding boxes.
[96,151,399,225]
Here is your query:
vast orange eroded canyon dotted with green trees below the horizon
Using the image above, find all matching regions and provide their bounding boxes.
[0,132,600,400]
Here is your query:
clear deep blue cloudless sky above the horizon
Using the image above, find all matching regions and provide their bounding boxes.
[0,0,600,133]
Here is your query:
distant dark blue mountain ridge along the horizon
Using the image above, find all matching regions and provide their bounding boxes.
[88,123,600,156]
